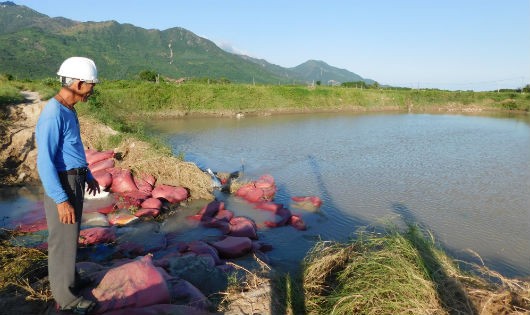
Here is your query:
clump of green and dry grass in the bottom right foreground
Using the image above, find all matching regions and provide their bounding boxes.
[303,226,530,314]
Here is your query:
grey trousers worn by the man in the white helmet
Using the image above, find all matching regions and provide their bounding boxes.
[44,174,85,307]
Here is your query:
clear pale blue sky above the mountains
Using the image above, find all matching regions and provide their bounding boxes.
[13,0,530,91]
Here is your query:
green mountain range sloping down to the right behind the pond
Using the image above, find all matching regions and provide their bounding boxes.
[0,2,372,84]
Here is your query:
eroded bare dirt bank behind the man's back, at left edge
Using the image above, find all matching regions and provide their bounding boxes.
[0,91,46,185]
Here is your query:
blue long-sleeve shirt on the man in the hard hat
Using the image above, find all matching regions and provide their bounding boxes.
[35,98,93,204]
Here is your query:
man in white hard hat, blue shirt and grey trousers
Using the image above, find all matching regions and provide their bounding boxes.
[35,57,99,314]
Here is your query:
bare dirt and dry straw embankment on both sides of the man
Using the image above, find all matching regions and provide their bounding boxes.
[0,91,213,199]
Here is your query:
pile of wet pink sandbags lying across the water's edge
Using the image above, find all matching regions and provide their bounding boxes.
[8,150,322,315]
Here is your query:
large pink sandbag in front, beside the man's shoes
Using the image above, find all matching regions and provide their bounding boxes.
[92,256,171,313]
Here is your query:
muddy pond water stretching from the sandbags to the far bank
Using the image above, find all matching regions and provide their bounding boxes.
[147,114,530,276]
